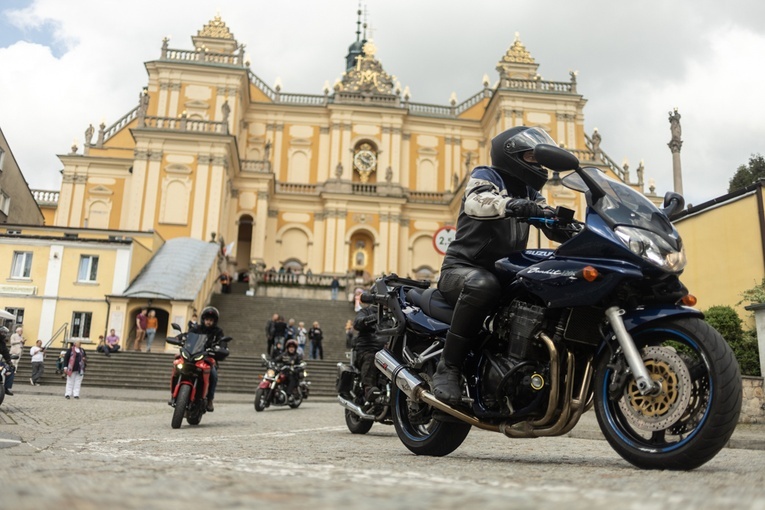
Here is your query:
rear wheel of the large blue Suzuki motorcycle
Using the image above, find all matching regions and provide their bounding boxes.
[391,388,472,457]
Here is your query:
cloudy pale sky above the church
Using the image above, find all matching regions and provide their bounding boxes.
[0,0,765,204]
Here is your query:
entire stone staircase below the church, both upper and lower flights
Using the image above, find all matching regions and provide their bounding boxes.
[6,283,355,397]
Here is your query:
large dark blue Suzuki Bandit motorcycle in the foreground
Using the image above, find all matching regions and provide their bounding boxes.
[370,145,742,470]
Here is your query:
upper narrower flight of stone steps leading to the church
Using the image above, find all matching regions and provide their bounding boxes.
[211,282,356,361]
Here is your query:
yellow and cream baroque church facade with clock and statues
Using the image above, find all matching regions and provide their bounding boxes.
[53,16,643,278]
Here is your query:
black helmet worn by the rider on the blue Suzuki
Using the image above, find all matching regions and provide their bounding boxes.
[491,126,557,191]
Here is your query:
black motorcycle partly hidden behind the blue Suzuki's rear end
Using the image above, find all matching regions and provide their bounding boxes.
[335,351,393,434]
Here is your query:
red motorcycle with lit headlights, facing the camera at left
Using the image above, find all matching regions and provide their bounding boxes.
[167,324,232,429]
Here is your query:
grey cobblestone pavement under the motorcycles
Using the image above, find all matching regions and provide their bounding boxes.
[0,385,765,510]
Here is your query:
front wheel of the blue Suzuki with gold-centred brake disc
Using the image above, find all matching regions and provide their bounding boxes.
[595,318,742,470]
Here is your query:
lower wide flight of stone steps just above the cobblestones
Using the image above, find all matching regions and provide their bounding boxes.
[14,350,344,398]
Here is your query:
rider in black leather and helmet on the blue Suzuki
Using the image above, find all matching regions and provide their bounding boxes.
[433,126,569,405]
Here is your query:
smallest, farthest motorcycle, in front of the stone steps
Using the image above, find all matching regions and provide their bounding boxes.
[255,354,311,412]
